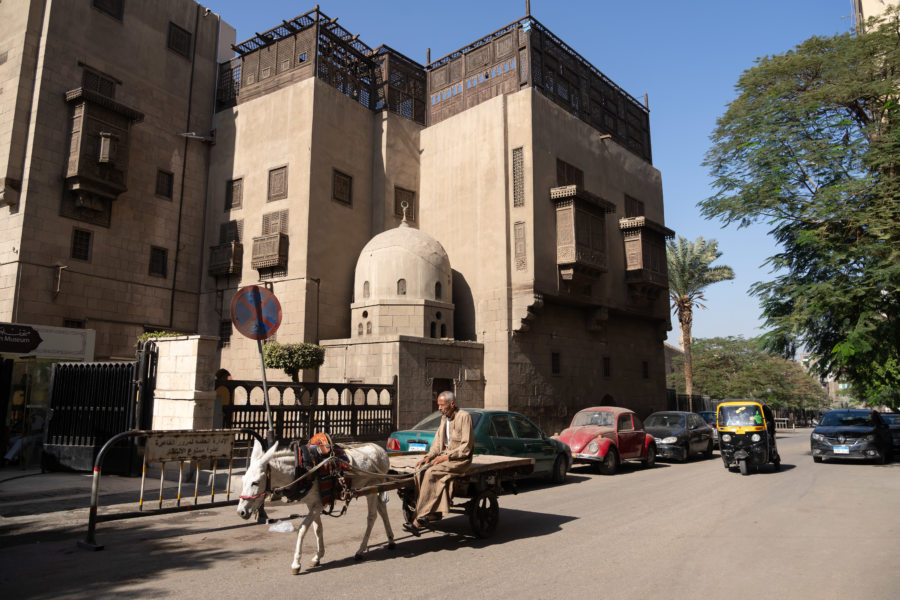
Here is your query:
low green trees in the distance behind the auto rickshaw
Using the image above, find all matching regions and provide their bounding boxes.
[668,337,828,409]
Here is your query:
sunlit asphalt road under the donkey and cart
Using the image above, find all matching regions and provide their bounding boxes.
[0,430,900,600]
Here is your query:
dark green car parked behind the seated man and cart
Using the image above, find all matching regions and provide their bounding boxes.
[387,408,572,483]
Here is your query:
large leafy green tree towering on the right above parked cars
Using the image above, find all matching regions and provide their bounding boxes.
[700,9,900,404]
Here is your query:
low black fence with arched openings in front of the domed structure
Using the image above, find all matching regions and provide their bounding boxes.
[216,377,397,442]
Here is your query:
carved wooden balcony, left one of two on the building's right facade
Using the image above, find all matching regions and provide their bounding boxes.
[550,185,615,281]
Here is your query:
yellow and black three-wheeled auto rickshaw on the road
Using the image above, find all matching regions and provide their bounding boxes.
[716,400,781,475]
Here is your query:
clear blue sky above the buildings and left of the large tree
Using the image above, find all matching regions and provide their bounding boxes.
[201,0,852,345]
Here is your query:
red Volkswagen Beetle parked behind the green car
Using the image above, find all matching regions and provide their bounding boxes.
[557,406,656,475]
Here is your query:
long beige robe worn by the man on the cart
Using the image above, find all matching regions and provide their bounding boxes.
[416,409,475,517]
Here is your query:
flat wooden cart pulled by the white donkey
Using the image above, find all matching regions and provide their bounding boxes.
[354,452,534,538]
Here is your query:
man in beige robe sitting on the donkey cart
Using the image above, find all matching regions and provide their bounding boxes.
[403,392,475,535]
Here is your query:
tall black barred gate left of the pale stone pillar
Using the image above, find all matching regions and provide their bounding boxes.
[41,342,157,475]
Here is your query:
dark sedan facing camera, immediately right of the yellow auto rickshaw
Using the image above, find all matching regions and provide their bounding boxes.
[809,408,891,464]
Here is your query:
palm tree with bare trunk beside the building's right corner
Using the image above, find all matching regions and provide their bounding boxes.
[666,235,734,412]
